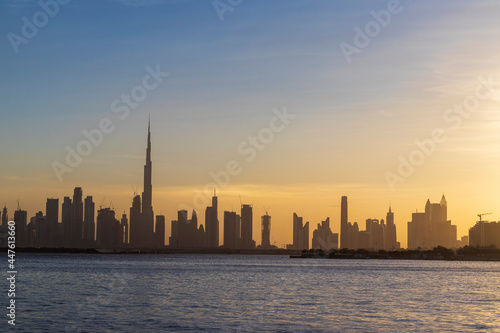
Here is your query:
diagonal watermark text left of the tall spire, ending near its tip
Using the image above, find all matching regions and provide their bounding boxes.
[51,65,169,182]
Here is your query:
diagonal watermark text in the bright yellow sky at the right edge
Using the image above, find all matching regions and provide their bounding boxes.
[384,74,500,192]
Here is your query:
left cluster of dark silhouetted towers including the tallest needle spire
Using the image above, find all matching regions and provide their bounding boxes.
[0,120,158,249]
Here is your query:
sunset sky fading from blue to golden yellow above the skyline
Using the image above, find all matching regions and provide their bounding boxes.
[0,0,500,247]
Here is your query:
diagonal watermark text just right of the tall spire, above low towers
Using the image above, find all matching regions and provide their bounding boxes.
[179,107,297,210]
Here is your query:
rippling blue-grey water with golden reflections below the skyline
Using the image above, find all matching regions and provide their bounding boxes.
[5,254,500,332]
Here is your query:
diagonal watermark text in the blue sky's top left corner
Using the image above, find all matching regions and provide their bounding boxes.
[7,0,70,54]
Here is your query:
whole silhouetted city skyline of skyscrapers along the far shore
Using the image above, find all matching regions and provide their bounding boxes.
[1,119,478,250]
